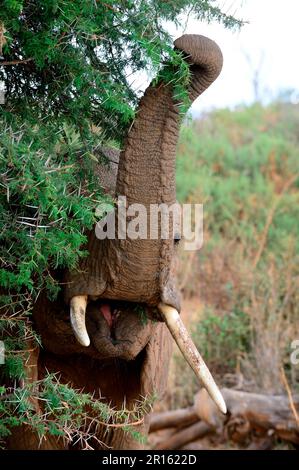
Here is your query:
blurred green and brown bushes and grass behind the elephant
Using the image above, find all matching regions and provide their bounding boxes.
[174,101,299,400]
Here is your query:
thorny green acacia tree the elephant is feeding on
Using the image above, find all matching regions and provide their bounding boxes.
[0,0,241,446]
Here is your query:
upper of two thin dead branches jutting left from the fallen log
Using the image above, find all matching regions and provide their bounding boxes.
[149,406,198,432]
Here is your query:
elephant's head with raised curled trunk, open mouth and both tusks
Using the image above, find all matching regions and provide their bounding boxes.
[65,35,226,412]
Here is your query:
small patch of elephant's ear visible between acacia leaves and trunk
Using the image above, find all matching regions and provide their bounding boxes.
[94,147,120,197]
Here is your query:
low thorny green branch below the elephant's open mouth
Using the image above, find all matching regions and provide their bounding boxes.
[0,374,155,449]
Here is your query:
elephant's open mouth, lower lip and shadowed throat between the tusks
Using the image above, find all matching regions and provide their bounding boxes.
[35,299,162,408]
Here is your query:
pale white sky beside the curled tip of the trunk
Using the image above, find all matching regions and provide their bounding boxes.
[159,0,299,116]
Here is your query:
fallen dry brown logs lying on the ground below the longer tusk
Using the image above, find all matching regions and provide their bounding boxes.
[150,388,299,450]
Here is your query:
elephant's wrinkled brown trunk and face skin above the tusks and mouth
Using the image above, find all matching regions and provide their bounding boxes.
[65,35,222,310]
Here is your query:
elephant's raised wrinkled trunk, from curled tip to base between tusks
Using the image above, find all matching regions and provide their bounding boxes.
[106,35,222,309]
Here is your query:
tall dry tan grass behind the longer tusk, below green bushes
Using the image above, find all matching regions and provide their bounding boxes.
[165,233,299,408]
